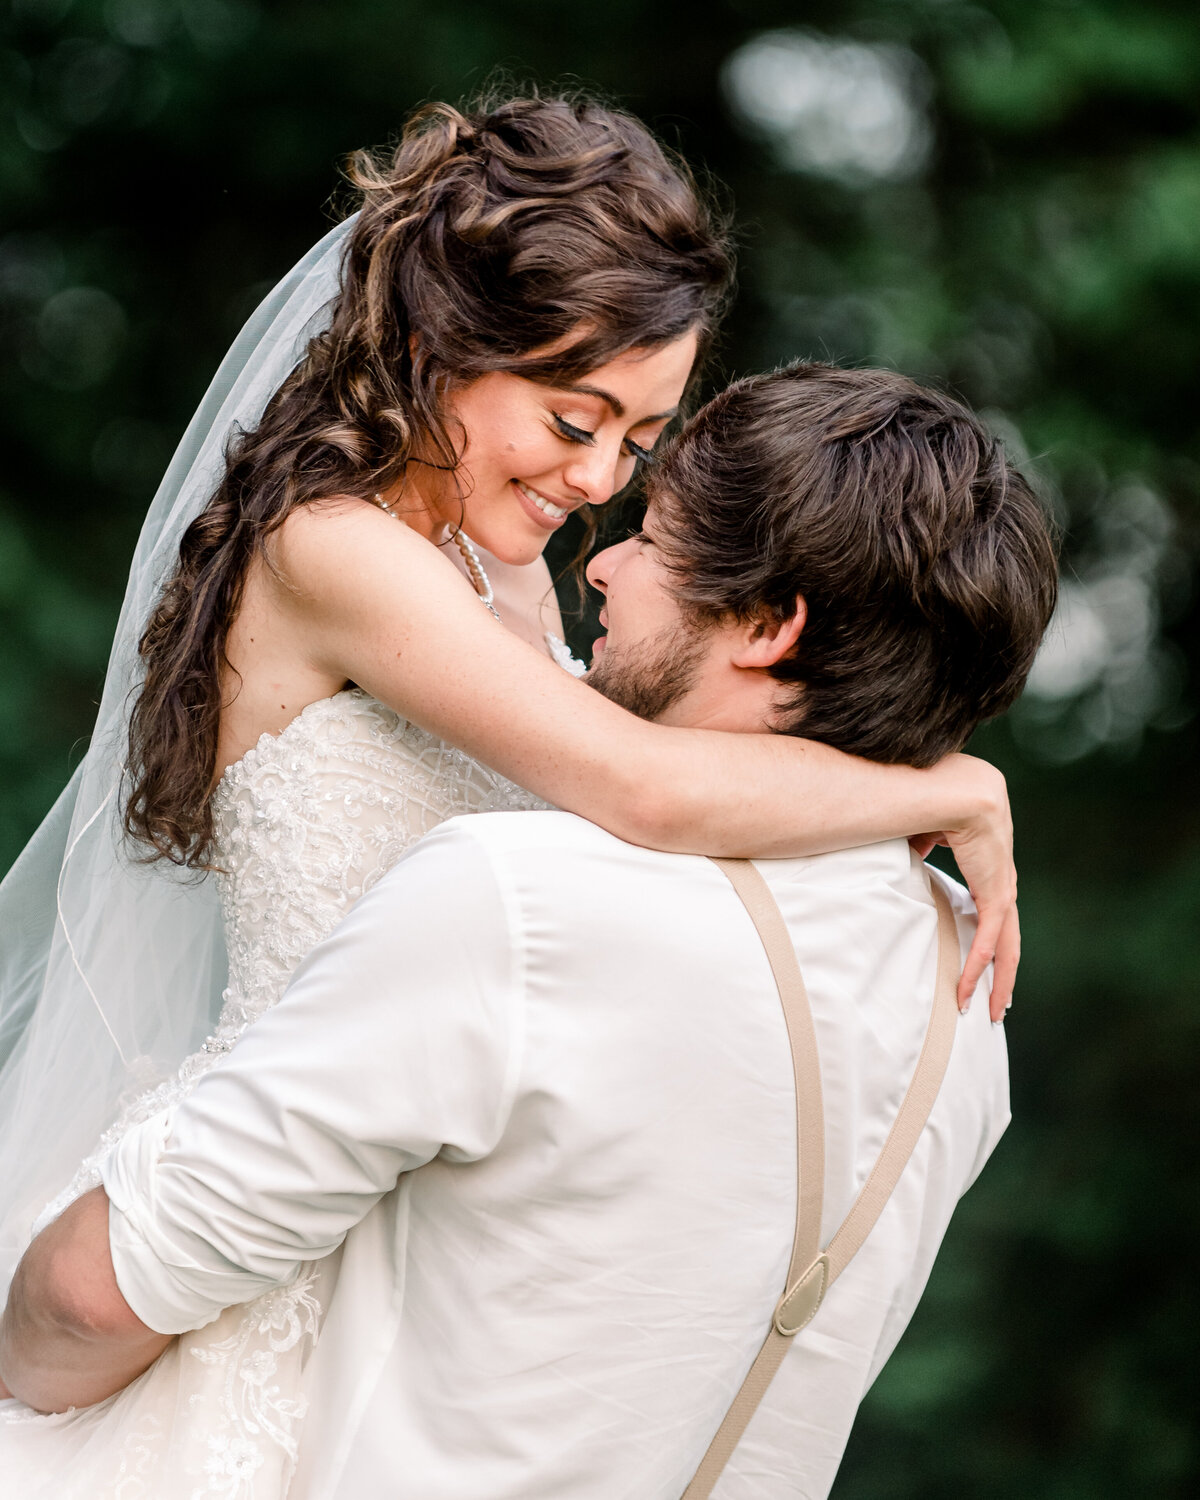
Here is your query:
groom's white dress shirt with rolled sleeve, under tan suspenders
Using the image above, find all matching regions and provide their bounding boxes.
[105,813,1008,1500]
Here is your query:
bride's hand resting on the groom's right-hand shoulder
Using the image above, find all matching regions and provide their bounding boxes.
[911,755,1022,1022]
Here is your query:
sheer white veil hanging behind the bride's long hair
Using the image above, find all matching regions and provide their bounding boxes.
[0,219,354,1302]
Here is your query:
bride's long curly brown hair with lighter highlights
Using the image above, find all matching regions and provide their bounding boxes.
[123,95,732,869]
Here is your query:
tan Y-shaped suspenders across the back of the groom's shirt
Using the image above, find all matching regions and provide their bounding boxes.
[683,860,960,1500]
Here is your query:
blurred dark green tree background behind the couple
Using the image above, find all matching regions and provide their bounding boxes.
[0,0,1200,1500]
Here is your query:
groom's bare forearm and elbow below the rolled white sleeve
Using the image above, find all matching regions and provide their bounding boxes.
[0,1188,171,1412]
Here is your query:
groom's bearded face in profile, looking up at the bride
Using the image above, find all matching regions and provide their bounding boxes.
[587,507,711,723]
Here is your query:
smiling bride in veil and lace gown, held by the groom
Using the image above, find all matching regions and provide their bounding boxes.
[0,98,1017,1500]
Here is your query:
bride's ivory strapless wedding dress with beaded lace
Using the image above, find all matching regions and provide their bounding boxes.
[0,687,552,1500]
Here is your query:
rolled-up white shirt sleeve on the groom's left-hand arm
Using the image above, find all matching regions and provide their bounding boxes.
[104,819,522,1334]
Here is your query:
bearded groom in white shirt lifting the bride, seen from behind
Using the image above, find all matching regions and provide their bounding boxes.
[0,366,1055,1500]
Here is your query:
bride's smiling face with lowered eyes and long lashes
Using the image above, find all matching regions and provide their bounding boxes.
[398,333,696,564]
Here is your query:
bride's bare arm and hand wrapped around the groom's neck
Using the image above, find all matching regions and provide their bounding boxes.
[275,503,1017,1019]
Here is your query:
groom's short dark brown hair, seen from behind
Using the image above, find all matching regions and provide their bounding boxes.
[648,365,1056,767]
